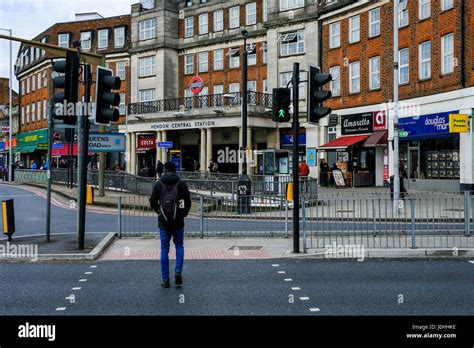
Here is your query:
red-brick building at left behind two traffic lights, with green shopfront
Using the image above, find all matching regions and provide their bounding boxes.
[15,13,131,167]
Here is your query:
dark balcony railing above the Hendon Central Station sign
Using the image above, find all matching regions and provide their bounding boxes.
[128,92,272,115]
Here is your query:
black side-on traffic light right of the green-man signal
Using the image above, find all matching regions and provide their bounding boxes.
[308,65,332,123]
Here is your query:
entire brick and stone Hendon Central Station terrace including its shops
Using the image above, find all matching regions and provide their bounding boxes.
[17,0,474,190]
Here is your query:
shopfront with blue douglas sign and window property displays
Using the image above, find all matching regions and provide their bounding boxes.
[399,111,460,191]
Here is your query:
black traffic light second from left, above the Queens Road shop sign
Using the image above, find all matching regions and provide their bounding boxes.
[94,66,121,126]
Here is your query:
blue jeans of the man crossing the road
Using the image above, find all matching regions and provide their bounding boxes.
[160,229,184,281]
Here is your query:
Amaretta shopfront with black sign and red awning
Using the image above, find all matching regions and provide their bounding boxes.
[319,111,388,187]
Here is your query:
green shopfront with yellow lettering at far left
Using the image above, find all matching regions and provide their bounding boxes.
[15,129,48,169]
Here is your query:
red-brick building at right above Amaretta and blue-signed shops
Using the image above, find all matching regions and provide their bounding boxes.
[319,0,474,190]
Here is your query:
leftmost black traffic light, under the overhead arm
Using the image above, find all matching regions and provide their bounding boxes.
[52,52,79,125]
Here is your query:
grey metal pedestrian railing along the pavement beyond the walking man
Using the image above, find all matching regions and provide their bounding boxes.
[118,192,474,249]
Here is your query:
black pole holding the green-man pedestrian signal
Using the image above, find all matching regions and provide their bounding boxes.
[292,63,300,254]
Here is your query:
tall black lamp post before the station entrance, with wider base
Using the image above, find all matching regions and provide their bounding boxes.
[237,30,251,214]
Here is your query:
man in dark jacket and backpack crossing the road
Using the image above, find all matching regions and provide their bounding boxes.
[150,162,191,288]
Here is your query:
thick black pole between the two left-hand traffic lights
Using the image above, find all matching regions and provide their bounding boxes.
[77,64,92,250]
